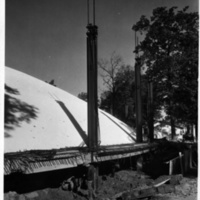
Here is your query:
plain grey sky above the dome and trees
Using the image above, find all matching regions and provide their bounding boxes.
[5,0,199,96]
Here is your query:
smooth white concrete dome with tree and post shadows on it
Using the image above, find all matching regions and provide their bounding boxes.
[4,67,136,153]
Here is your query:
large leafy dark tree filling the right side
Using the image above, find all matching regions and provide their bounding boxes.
[133,7,198,138]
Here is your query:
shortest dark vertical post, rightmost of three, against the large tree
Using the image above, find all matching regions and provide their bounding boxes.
[148,82,154,142]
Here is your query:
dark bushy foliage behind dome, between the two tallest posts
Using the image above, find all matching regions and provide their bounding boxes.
[100,65,135,126]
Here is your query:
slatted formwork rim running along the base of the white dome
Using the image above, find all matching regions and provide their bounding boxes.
[4,143,157,175]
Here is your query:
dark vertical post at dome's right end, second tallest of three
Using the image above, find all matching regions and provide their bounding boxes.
[135,57,143,143]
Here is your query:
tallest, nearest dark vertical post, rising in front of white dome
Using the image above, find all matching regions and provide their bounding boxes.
[87,24,98,151]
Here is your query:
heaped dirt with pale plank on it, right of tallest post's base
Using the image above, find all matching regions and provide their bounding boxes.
[95,171,197,200]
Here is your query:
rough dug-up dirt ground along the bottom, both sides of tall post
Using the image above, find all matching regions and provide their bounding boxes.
[4,170,197,200]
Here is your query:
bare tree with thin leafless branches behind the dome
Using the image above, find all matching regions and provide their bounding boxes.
[98,52,122,115]
